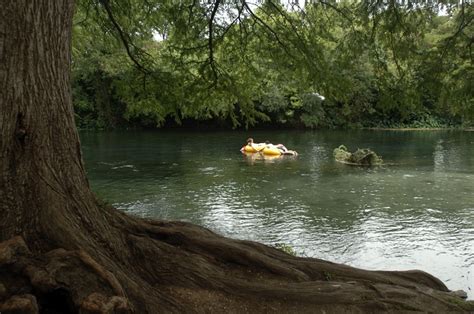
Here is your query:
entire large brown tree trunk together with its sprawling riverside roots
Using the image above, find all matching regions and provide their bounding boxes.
[0,0,474,313]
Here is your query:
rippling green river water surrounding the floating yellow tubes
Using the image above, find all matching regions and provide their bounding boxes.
[81,130,474,299]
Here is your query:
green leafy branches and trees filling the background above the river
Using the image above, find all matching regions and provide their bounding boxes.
[73,0,474,128]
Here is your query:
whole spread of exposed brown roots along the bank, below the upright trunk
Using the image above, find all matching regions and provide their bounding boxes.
[0,209,474,313]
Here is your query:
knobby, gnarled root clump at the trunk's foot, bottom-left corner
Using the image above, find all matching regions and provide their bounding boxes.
[0,237,131,313]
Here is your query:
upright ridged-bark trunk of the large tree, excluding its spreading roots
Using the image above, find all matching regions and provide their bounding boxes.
[0,0,100,249]
